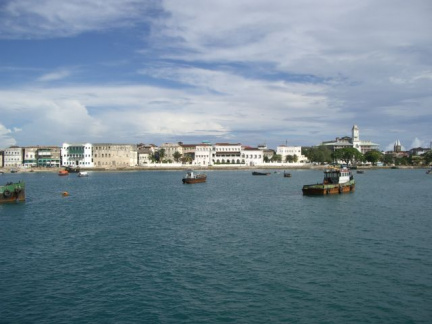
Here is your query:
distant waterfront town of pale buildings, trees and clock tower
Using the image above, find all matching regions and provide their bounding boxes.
[0,125,432,169]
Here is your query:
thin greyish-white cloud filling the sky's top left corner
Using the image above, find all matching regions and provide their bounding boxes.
[0,0,155,38]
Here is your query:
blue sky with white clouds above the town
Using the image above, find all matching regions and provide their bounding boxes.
[0,0,432,150]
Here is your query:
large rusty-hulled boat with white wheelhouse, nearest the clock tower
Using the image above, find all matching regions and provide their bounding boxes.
[302,167,355,195]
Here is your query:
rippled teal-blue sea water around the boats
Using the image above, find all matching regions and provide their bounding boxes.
[0,170,432,323]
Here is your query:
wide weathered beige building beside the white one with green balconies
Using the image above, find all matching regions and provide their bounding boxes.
[93,143,138,168]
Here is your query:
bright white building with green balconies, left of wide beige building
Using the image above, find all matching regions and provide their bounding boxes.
[61,143,94,168]
